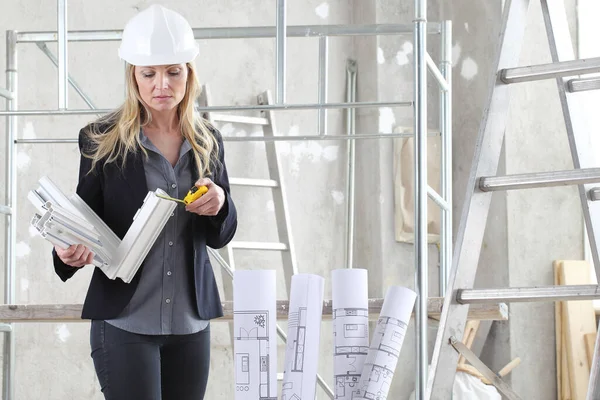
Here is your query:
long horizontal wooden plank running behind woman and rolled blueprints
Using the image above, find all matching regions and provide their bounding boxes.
[0,297,508,322]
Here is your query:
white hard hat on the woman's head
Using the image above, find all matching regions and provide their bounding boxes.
[119,5,198,66]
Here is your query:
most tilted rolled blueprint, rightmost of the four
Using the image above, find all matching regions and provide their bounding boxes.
[352,286,417,400]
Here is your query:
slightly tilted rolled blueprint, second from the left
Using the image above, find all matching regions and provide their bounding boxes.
[281,274,325,400]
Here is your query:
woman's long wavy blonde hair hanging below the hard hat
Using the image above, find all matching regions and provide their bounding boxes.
[83,63,219,177]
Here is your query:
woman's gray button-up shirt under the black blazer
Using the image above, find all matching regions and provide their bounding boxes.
[106,133,208,335]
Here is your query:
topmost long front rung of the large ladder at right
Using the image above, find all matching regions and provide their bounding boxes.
[500,57,600,83]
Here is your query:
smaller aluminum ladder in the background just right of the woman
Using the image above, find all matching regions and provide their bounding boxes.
[198,84,334,399]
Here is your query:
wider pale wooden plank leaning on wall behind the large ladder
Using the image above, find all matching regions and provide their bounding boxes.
[560,261,596,400]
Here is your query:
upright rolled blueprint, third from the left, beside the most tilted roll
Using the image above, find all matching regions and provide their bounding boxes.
[331,268,369,400]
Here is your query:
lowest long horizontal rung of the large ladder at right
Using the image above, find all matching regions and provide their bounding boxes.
[456,285,600,304]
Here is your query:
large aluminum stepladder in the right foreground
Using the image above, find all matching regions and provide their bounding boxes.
[424,0,600,400]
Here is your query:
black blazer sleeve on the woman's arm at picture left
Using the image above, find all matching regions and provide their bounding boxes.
[52,129,104,282]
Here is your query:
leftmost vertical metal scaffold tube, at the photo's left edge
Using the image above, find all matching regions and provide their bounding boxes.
[2,31,19,400]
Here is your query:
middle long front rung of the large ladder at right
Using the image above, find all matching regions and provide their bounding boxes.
[479,168,600,192]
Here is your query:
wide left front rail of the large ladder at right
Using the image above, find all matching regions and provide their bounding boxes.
[425,0,529,399]
